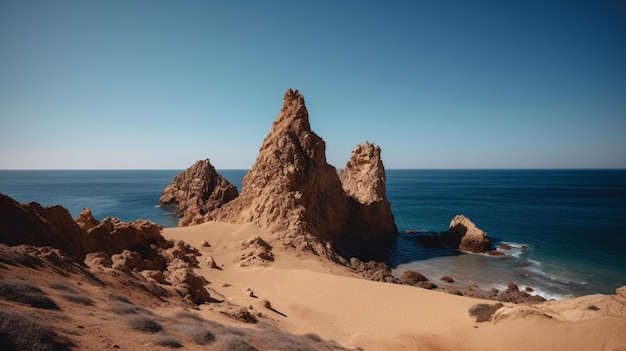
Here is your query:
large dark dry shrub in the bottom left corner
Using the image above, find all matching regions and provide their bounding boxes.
[0,310,73,351]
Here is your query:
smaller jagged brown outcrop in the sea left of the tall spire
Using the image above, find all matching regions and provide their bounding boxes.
[159,159,239,227]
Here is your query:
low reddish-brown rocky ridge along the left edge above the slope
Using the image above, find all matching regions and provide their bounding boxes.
[0,194,210,304]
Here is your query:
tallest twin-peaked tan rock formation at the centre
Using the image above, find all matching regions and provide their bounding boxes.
[205,89,396,254]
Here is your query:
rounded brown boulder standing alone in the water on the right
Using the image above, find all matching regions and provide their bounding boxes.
[441,215,491,252]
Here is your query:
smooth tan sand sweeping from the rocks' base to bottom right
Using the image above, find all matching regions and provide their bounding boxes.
[163,222,626,350]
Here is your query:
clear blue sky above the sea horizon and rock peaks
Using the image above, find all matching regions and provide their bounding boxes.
[0,0,626,169]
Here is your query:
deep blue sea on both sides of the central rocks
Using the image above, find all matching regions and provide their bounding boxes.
[0,169,626,299]
